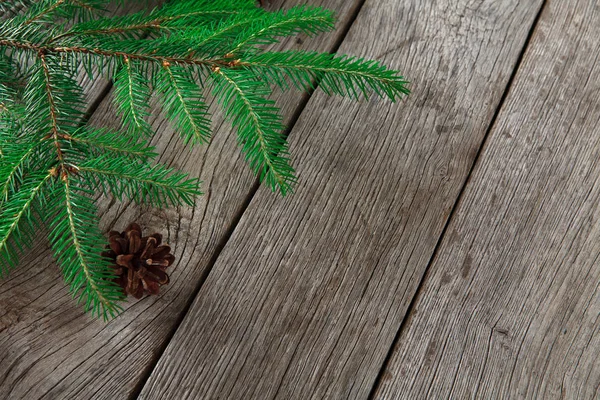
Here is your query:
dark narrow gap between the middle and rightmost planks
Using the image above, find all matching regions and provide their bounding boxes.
[368,0,548,400]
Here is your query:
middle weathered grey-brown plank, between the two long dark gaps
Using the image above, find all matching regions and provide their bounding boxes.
[141,0,541,399]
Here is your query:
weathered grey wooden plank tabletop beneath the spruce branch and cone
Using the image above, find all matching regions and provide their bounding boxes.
[0,0,600,400]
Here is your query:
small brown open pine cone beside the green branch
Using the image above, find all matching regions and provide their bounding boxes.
[102,223,175,299]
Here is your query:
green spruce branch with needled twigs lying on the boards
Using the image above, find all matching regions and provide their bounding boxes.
[0,0,408,318]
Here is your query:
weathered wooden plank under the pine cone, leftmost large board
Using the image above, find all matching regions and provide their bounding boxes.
[0,0,358,400]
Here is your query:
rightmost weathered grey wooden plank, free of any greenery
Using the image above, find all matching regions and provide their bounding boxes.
[376,0,600,399]
